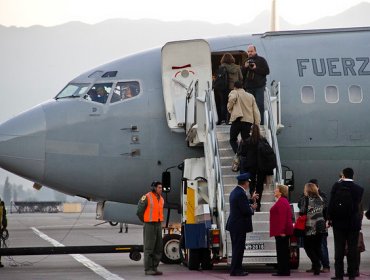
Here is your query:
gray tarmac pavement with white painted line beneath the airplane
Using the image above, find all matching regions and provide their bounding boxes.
[0,209,370,280]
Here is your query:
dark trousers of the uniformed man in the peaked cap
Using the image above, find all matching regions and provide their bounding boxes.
[230,230,246,274]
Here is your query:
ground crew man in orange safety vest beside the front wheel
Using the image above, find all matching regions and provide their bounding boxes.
[137,181,164,275]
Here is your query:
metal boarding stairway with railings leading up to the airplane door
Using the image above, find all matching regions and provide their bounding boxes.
[189,84,282,264]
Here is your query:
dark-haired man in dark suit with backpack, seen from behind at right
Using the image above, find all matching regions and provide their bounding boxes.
[328,168,364,280]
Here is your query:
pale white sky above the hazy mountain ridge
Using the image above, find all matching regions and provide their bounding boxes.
[0,0,370,27]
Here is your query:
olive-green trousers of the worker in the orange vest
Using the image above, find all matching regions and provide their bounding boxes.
[143,222,163,271]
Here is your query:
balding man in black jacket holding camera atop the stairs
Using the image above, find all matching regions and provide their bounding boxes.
[242,45,270,125]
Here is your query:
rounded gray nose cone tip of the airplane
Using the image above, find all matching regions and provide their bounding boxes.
[0,105,46,182]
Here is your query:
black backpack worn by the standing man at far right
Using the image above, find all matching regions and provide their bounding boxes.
[332,184,354,220]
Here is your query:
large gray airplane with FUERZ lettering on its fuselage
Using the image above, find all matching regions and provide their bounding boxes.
[0,27,370,223]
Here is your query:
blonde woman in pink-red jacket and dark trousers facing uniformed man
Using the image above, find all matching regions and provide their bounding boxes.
[270,185,293,276]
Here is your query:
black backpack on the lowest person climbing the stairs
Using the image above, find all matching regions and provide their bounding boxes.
[257,139,277,175]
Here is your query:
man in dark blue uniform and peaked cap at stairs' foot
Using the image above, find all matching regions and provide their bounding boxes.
[226,173,258,276]
